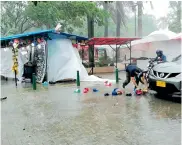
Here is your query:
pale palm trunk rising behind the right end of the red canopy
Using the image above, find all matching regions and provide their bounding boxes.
[137,1,143,37]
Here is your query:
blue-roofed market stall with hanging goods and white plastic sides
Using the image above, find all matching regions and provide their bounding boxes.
[0,30,87,86]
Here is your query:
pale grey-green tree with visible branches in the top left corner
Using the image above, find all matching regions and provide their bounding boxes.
[1,1,35,36]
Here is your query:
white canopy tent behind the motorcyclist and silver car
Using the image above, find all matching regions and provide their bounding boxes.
[121,30,181,68]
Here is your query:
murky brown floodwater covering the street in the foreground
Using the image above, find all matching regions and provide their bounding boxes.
[1,72,181,145]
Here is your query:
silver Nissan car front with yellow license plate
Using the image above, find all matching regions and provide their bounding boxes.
[149,55,182,97]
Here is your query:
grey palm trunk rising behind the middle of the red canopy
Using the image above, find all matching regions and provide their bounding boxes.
[116,1,121,37]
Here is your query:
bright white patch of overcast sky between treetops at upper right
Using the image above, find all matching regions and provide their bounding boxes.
[144,0,169,19]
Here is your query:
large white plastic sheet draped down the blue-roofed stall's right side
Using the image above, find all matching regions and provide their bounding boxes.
[48,39,88,82]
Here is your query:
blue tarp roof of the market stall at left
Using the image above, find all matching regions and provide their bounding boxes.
[0,30,88,41]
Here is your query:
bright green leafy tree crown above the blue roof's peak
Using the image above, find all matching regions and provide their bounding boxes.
[26,1,104,33]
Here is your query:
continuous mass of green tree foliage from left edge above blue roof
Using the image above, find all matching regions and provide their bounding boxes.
[1,1,108,36]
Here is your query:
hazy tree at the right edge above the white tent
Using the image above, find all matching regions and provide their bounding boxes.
[168,1,181,33]
